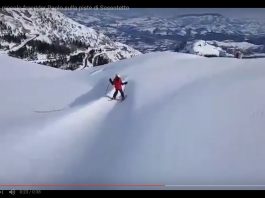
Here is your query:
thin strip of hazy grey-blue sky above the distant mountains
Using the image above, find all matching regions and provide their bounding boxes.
[127,8,265,21]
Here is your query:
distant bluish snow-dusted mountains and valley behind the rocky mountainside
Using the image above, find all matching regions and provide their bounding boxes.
[62,10,265,53]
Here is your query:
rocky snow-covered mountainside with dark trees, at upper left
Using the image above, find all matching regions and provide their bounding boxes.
[0,8,140,69]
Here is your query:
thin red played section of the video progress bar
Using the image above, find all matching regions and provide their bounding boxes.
[0,184,165,187]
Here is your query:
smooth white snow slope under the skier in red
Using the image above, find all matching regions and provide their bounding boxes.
[0,52,265,189]
